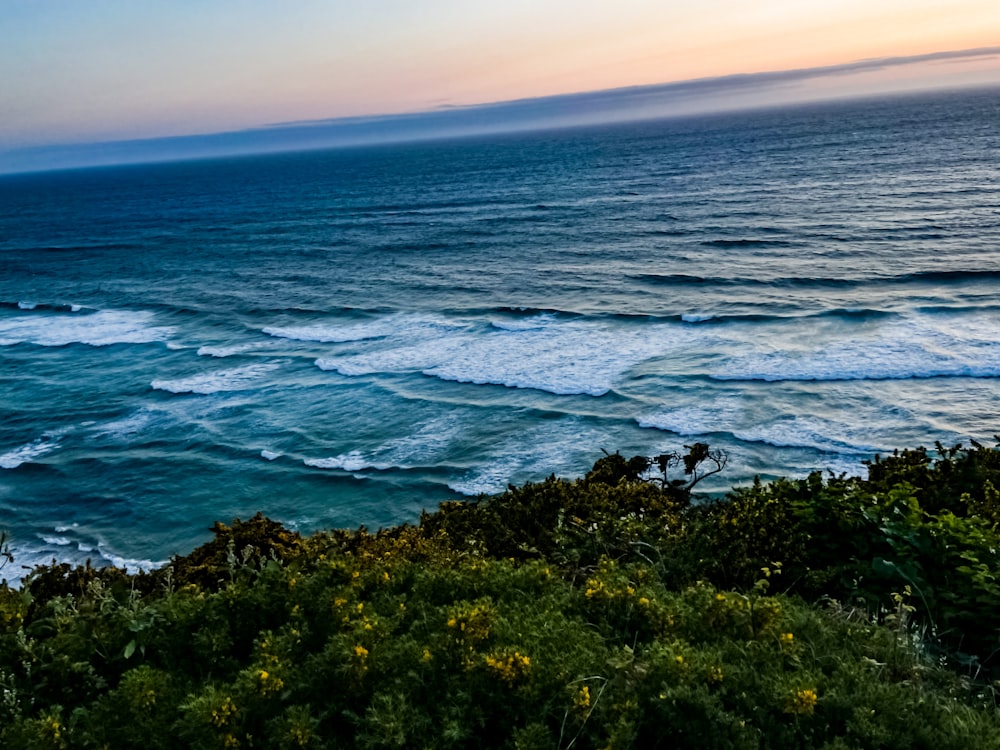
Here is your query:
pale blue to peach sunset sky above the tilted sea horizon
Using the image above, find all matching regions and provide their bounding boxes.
[0,0,1000,171]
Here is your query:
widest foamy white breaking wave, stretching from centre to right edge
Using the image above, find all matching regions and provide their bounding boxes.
[300,307,1000,397]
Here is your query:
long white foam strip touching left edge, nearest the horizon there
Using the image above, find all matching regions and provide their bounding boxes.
[0,310,173,346]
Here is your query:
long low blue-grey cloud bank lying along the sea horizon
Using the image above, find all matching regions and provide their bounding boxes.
[0,47,1000,173]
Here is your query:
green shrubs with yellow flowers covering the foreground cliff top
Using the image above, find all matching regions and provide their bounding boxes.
[0,444,1000,750]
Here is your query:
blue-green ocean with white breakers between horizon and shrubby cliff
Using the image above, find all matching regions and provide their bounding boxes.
[0,89,1000,578]
